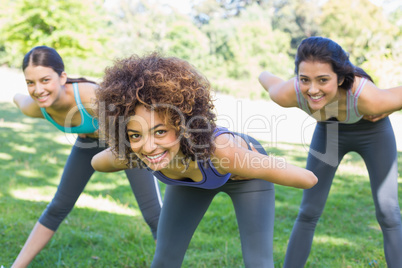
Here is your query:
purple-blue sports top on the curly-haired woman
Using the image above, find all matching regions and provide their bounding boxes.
[147,127,233,189]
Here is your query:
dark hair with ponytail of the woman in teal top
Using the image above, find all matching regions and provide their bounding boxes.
[22,46,96,84]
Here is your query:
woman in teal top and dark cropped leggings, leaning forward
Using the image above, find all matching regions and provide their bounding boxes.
[12,46,161,267]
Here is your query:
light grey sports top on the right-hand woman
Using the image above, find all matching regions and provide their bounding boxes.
[294,77,367,124]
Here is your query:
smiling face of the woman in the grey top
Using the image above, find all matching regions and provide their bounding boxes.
[298,61,338,111]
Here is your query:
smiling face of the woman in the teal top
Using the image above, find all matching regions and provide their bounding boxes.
[24,65,67,108]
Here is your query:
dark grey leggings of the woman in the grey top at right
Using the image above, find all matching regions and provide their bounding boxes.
[284,117,402,268]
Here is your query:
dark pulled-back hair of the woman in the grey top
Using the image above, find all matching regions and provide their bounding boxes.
[295,36,373,90]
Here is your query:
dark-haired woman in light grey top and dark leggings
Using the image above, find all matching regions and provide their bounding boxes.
[259,37,402,268]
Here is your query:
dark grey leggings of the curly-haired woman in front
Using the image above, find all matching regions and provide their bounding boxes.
[151,135,275,268]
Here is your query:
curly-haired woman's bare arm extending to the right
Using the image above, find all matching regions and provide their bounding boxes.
[213,135,318,189]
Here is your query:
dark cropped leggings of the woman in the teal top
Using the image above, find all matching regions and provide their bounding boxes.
[39,137,162,239]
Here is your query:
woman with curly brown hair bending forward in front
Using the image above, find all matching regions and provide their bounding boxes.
[92,53,317,268]
